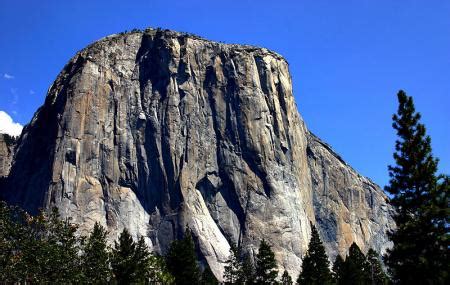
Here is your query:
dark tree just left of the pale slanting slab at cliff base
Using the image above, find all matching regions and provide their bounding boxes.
[166,226,200,284]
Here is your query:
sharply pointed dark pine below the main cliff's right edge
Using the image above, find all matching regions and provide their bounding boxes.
[297,224,332,285]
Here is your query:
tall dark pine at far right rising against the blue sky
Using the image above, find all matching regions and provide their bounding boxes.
[385,91,450,284]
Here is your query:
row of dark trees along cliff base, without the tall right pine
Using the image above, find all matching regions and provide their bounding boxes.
[0,202,387,284]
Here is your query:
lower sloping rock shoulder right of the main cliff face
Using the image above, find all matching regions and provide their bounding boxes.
[307,133,394,260]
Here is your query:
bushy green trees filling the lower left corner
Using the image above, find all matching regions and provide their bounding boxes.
[0,202,82,283]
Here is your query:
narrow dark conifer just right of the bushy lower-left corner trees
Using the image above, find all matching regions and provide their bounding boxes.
[81,223,111,284]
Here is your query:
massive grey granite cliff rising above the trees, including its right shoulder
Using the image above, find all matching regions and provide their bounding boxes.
[1,30,393,278]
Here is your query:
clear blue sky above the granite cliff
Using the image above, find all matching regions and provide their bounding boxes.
[0,0,450,186]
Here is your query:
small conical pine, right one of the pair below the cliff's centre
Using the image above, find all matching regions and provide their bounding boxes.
[255,239,278,284]
